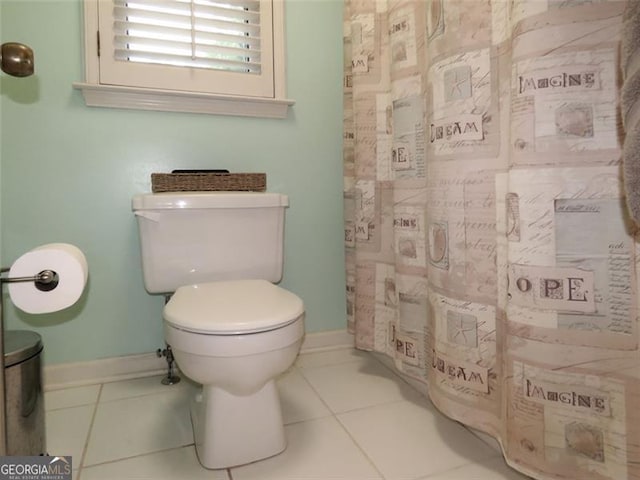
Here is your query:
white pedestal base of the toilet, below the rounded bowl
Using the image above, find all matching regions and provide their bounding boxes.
[191,380,287,469]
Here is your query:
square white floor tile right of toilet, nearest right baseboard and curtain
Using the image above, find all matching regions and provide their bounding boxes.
[301,356,420,413]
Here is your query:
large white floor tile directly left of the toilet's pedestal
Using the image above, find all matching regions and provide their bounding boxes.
[85,390,193,465]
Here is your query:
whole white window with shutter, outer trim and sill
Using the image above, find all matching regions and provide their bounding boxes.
[74,0,293,118]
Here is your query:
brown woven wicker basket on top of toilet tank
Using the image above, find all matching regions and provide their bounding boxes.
[151,173,267,193]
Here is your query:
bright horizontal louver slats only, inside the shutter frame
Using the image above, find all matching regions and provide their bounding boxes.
[114,0,260,73]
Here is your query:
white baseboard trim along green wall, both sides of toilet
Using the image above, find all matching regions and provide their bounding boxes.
[43,330,353,391]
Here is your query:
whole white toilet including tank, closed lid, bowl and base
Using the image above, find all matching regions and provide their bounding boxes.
[132,192,304,469]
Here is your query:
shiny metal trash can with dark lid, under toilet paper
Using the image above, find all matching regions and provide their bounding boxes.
[4,330,46,455]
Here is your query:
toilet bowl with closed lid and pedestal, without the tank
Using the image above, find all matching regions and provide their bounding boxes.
[163,280,304,469]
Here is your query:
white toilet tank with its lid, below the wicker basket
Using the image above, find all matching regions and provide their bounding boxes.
[132,192,289,293]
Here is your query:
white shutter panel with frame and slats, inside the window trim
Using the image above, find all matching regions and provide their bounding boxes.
[98,0,274,98]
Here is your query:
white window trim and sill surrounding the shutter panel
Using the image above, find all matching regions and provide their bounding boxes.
[73,0,295,118]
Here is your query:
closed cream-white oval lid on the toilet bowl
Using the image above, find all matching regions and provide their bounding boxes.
[163,280,304,335]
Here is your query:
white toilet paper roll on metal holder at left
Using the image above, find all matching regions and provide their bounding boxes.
[8,243,89,313]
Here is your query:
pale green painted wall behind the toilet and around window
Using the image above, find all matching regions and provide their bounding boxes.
[0,0,345,365]
